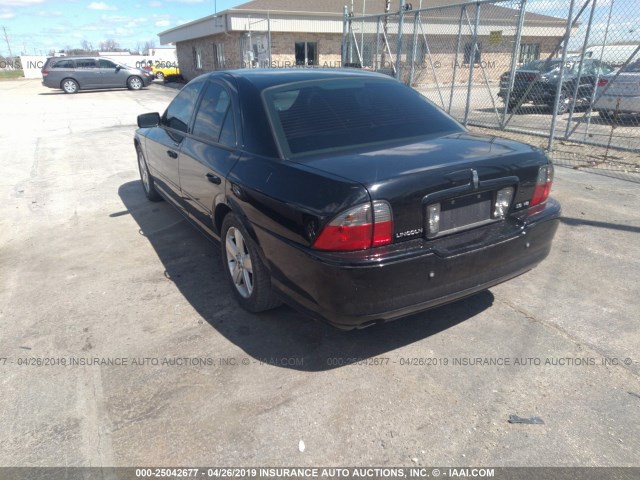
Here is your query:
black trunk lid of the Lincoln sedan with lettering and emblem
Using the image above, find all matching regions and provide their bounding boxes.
[304,132,548,242]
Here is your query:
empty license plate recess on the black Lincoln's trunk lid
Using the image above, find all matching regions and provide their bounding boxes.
[425,191,494,238]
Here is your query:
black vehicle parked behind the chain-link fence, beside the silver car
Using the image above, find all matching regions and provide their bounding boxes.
[498,58,613,113]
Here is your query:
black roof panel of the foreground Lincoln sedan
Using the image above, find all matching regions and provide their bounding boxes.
[196,67,396,90]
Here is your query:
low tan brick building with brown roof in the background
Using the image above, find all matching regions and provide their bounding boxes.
[159,0,566,83]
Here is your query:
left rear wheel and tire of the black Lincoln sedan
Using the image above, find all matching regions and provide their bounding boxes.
[220,213,281,313]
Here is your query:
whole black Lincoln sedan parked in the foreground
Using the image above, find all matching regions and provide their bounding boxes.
[134,69,560,329]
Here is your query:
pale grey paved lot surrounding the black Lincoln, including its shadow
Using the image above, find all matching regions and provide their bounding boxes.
[0,80,640,467]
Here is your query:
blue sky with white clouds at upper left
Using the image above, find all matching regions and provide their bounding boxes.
[0,0,248,56]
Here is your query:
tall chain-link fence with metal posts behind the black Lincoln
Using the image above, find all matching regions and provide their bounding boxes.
[341,0,640,181]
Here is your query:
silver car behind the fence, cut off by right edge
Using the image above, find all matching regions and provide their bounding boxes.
[593,60,640,119]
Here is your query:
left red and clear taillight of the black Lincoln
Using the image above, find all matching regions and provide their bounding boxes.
[313,201,393,252]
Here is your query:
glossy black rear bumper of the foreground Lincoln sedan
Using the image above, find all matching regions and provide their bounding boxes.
[256,199,560,329]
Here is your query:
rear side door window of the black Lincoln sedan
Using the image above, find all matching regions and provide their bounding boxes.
[193,83,235,145]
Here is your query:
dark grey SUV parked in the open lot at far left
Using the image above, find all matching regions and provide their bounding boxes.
[41,57,153,93]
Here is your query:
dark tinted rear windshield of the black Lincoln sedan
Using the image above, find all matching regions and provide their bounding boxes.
[264,79,463,156]
